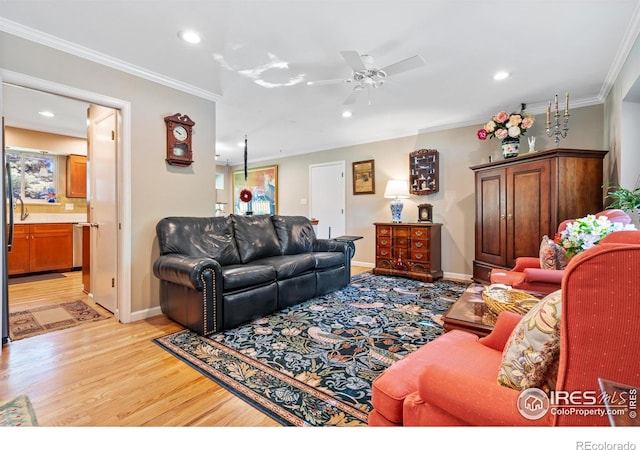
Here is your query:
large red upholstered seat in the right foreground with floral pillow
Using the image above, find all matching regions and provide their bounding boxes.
[369,231,640,426]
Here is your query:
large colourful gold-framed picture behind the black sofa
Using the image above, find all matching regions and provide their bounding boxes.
[231,166,278,215]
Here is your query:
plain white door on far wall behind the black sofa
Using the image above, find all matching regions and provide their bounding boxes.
[309,161,346,239]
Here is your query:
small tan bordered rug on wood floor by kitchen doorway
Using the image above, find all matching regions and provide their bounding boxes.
[9,300,110,341]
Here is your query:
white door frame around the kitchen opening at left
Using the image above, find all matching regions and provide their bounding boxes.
[0,69,131,323]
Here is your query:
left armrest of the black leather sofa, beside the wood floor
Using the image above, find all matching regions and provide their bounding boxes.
[153,253,222,291]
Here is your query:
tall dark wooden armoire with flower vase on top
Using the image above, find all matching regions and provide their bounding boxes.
[471,148,607,283]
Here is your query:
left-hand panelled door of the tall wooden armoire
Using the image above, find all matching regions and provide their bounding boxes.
[476,169,507,266]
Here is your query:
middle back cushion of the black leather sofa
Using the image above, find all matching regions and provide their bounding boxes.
[230,214,281,264]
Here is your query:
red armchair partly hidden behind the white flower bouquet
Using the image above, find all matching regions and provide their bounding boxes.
[491,209,631,294]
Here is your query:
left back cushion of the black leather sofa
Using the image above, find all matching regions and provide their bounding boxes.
[156,217,240,266]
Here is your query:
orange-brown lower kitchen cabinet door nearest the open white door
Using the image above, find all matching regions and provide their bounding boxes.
[29,223,73,272]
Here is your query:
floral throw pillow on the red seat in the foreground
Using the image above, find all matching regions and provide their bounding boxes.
[498,289,562,390]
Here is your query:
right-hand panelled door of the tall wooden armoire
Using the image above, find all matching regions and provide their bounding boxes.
[506,160,553,267]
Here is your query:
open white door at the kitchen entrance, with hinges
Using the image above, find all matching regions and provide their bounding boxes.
[87,105,118,316]
